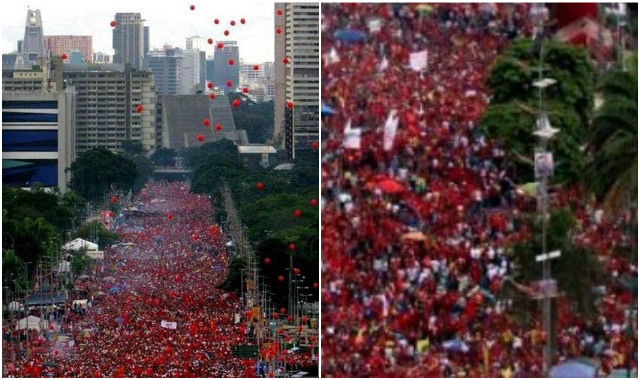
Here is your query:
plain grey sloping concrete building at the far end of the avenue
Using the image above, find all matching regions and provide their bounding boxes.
[158,92,248,149]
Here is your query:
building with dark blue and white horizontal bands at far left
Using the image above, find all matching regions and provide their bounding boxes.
[2,57,76,192]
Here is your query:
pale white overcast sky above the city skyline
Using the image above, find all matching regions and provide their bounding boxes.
[2,0,275,63]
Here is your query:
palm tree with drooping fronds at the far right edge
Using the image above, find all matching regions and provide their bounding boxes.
[586,70,638,214]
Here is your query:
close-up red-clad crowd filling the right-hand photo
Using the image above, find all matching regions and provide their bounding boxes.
[321,4,637,377]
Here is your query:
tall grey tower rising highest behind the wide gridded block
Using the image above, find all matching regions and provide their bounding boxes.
[113,13,149,70]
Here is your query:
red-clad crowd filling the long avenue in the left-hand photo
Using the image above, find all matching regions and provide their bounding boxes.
[3,182,312,377]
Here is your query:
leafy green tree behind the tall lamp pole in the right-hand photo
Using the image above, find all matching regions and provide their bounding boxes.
[480,39,594,183]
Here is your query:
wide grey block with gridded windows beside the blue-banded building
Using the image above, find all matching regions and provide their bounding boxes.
[64,64,156,154]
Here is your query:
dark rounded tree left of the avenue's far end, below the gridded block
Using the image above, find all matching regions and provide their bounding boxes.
[71,148,139,200]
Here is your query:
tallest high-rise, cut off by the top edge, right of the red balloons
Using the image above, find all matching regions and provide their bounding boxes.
[274,3,320,158]
